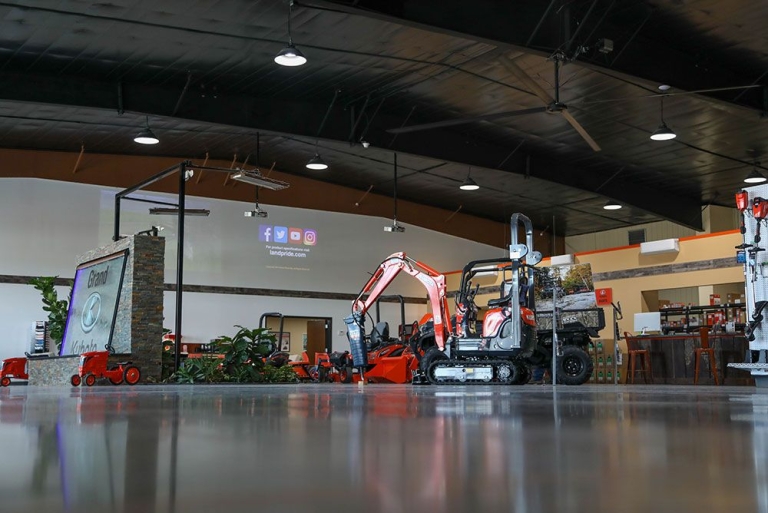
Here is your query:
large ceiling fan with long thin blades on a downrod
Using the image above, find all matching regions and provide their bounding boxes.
[387,52,600,151]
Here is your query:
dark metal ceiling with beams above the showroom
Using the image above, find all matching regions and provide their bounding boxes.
[0,0,768,235]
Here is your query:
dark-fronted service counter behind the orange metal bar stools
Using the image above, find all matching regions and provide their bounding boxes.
[627,333,755,386]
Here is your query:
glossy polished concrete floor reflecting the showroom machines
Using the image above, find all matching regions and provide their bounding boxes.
[0,384,768,513]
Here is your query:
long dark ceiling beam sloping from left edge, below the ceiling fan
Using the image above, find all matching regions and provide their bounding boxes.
[0,72,702,230]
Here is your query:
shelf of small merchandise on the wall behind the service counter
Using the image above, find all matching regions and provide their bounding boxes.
[659,303,746,335]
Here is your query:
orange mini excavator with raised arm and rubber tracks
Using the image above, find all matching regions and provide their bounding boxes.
[344,210,541,384]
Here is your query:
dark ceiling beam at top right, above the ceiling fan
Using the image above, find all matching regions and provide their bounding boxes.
[314,0,764,113]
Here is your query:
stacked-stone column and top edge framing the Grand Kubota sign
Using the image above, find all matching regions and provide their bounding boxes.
[77,235,165,381]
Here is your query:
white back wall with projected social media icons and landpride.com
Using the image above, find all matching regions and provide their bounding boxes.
[0,178,506,358]
